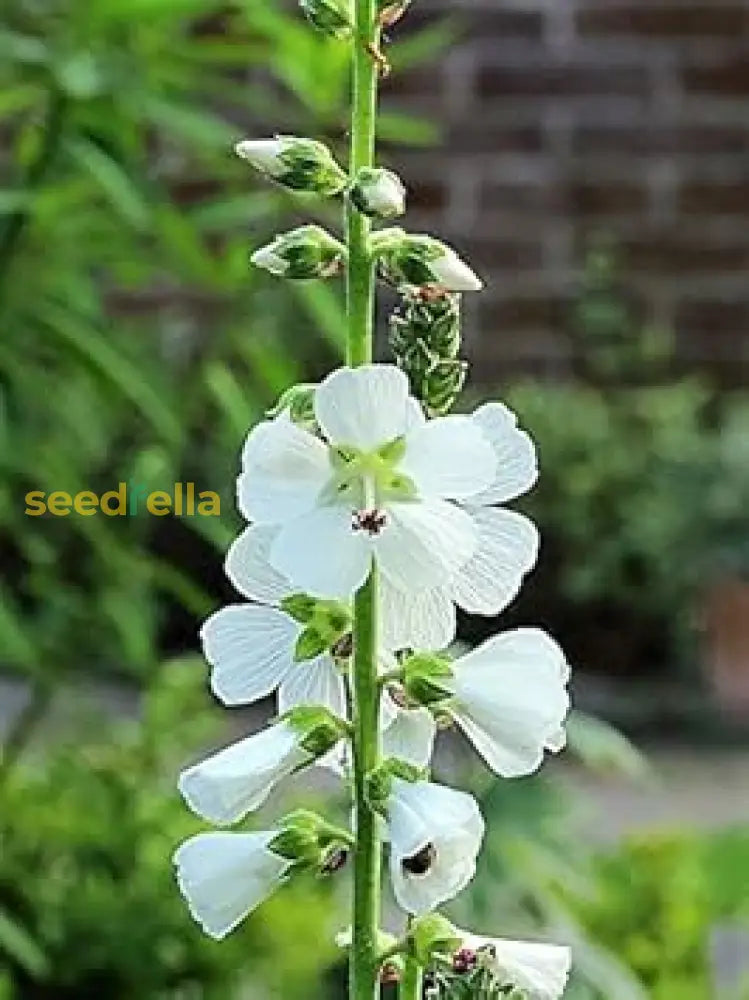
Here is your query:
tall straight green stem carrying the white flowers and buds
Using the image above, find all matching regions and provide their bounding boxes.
[346,0,381,1000]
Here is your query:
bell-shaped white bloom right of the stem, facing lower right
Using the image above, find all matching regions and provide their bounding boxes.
[440,628,570,778]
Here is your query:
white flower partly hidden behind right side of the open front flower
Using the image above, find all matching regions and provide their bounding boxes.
[380,403,539,649]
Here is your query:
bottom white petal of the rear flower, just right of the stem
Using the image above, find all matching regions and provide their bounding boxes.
[379,576,457,651]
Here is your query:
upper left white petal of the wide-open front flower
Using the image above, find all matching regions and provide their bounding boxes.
[237,416,331,524]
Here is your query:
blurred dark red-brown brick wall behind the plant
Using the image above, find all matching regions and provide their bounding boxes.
[384,0,749,385]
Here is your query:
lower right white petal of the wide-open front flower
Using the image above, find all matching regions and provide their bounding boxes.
[373,500,477,591]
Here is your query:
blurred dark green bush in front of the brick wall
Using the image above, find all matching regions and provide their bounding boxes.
[506,251,749,672]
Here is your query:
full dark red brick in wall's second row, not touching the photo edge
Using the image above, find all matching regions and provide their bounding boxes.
[478,65,650,99]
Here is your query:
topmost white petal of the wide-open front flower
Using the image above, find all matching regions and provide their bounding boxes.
[315,365,408,451]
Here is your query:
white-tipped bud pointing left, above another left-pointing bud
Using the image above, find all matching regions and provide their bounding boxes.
[234,135,348,198]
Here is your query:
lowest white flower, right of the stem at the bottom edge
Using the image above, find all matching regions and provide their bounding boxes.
[459,932,572,1000]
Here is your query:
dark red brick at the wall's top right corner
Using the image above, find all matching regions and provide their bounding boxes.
[577,3,749,39]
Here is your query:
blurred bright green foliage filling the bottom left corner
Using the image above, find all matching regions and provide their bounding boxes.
[0,658,340,1000]
